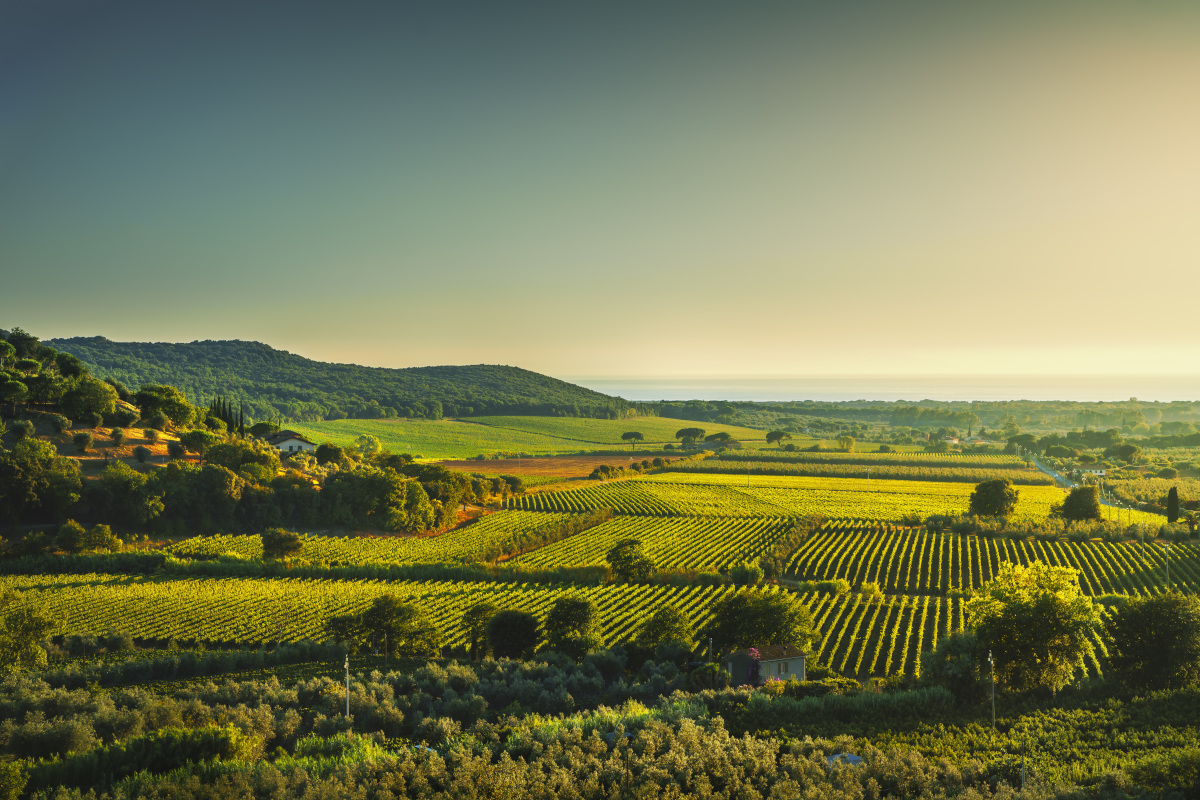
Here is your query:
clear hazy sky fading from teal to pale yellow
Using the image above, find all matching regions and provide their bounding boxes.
[0,0,1200,377]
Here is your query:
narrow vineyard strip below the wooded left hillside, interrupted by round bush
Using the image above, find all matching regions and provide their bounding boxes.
[167,511,570,565]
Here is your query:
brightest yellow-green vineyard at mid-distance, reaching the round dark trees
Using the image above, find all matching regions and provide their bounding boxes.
[509,471,1080,522]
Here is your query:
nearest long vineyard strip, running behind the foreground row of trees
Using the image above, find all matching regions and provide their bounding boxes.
[0,575,1084,678]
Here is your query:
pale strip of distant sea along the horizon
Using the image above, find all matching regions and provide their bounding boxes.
[563,374,1200,402]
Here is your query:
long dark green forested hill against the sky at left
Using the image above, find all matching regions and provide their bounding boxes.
[46,336,630,421]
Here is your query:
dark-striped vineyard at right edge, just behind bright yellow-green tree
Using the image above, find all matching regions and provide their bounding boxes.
[788,521,1200,595]
